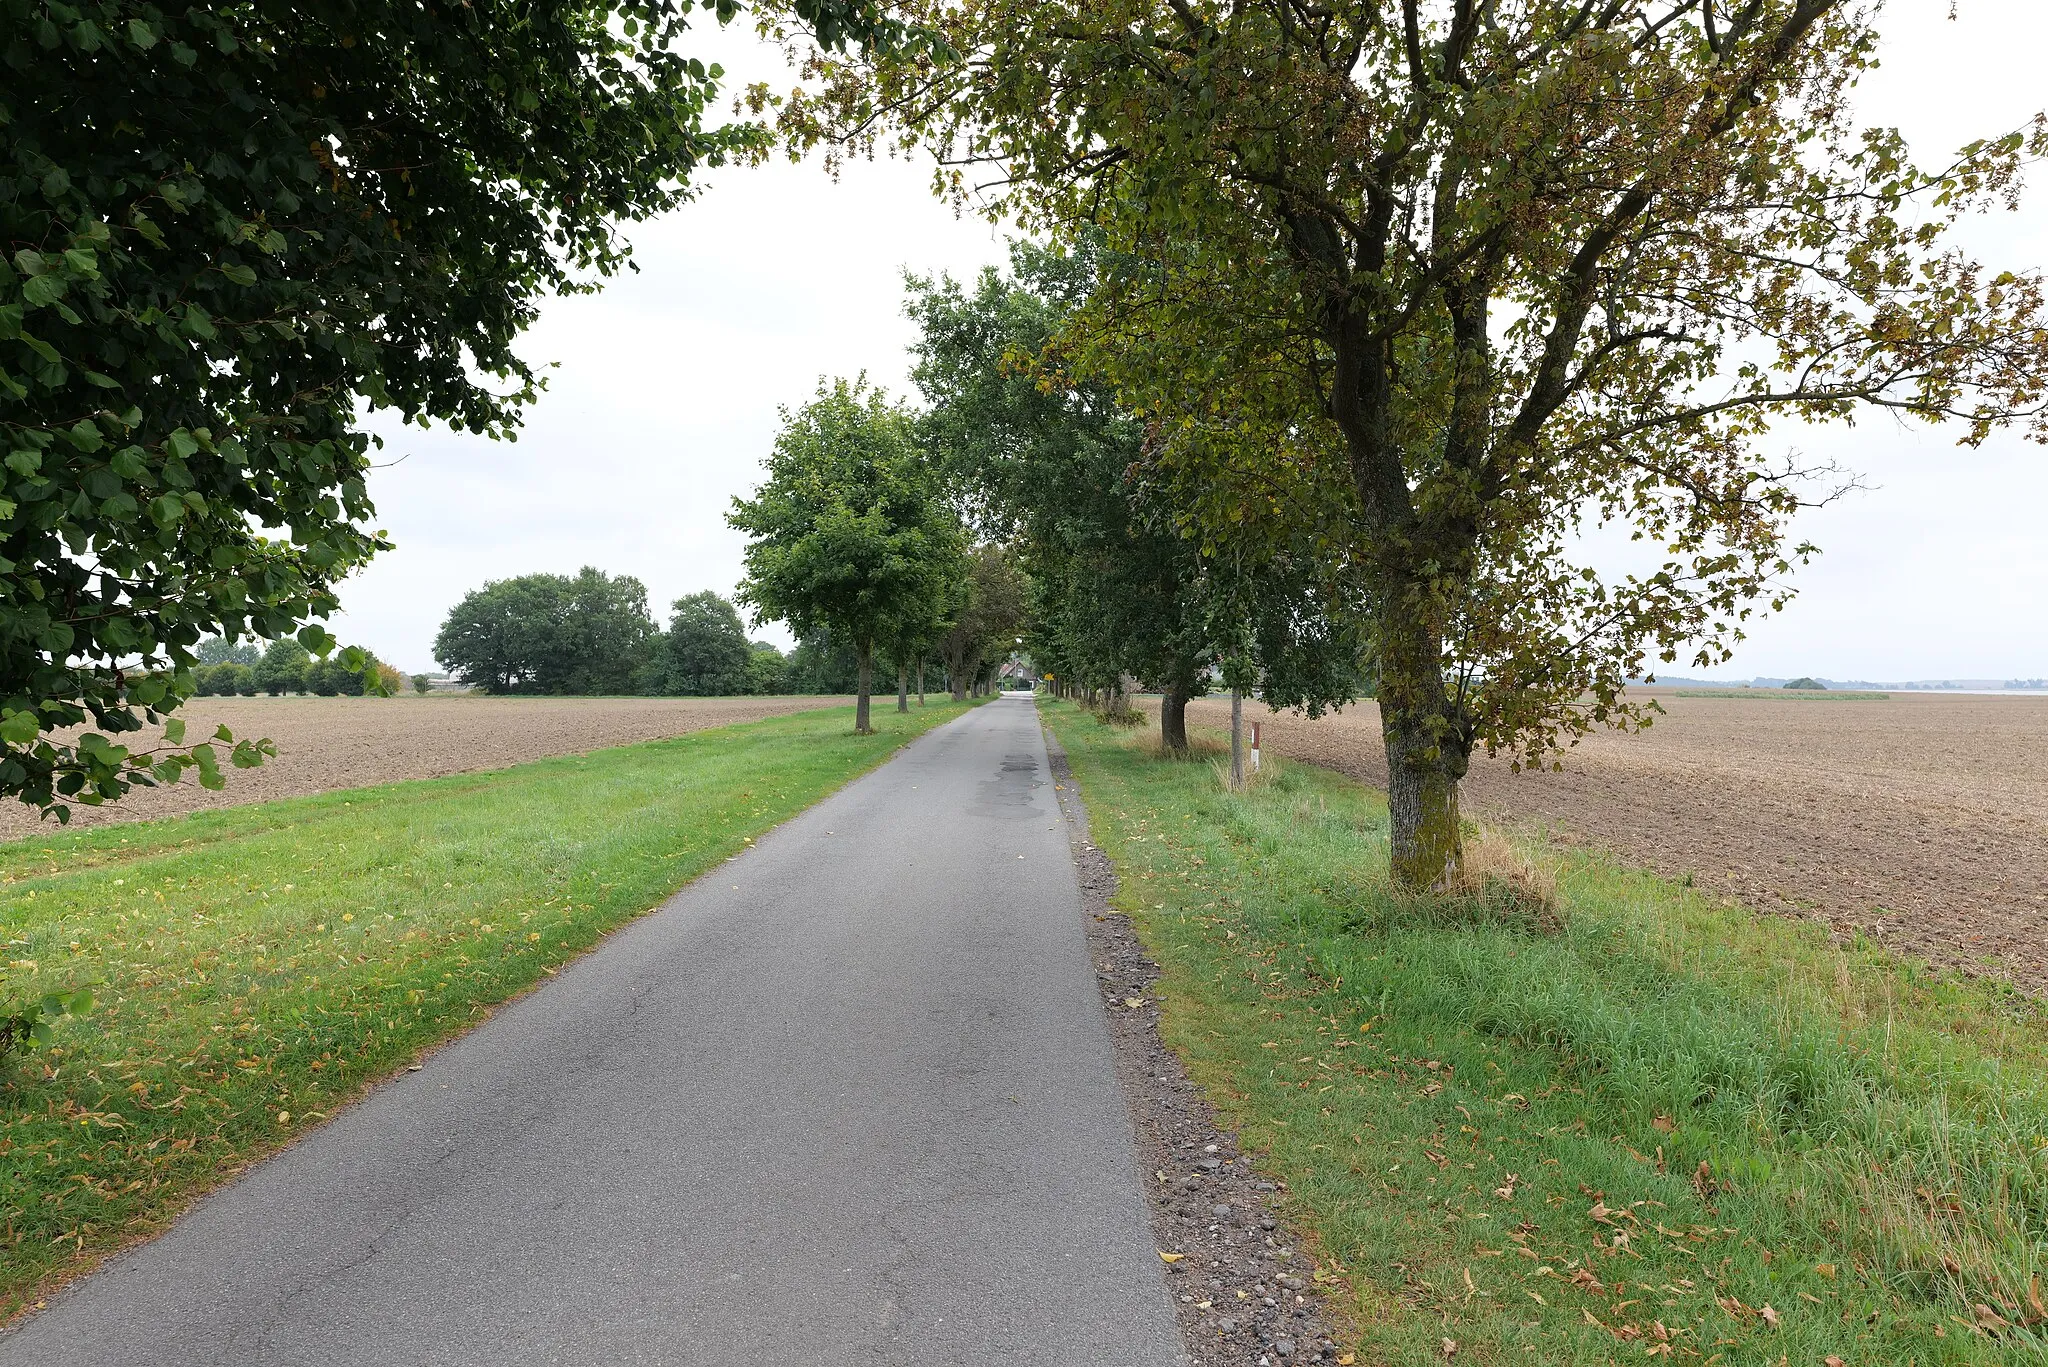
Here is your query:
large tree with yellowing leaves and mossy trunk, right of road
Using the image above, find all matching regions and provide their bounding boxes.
[784,0,2048,887]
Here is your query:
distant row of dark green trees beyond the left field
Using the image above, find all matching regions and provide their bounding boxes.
[434,566,858,697]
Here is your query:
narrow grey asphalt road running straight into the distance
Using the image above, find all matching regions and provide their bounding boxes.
[0,699,1186,1367]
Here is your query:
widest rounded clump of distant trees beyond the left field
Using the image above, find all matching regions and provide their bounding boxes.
[434,566,659,695]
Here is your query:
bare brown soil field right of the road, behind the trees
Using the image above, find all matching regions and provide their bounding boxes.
[1153,689,2048,992]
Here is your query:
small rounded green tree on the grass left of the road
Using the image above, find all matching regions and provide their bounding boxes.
[725,379,963,726]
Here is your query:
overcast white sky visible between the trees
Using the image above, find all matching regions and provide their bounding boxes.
[336,0,2048,680]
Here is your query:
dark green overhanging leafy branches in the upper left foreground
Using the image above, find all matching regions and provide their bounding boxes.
[0,0,893,823]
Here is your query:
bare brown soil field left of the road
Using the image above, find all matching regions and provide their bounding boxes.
[0,695,848,840]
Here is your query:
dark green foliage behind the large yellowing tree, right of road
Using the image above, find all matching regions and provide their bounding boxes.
[909,244,1364,709]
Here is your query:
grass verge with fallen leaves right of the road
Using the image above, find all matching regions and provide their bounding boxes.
[1047,703,2048,1367]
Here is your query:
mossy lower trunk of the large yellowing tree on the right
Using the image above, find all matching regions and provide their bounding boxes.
[1378,625,1473,892]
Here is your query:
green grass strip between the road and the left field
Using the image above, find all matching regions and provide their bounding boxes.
[0,703,965,1320]
